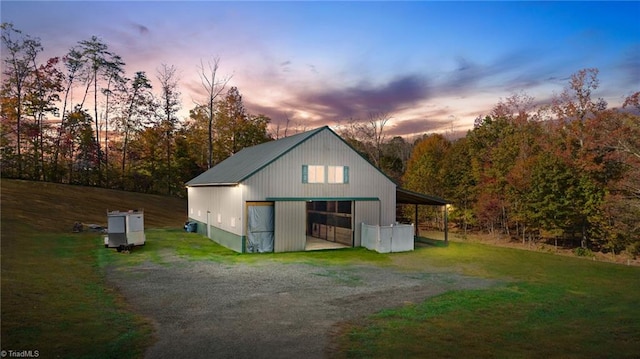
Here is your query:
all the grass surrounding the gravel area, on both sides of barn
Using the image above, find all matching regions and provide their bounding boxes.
[1,180,640,358]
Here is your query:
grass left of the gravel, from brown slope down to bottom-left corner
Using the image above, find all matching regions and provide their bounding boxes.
[0,180,186,358]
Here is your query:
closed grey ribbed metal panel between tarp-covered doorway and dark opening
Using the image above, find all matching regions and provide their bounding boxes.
[274,201,307,252]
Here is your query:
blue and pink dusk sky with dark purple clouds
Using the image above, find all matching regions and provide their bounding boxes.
[0,1,640,136]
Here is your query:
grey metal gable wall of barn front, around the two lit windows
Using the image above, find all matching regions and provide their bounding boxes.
[245,131,396,225]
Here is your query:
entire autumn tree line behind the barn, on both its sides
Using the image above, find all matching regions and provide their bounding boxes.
[0,23,640,254]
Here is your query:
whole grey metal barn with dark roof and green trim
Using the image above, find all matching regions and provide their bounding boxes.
[186,126,445,253]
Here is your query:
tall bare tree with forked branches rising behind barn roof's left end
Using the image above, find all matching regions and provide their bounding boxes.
[198,57,231,168]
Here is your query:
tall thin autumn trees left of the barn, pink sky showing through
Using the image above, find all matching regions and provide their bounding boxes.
[0,23,271,196]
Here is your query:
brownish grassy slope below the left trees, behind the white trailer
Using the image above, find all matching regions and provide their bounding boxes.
[0,179,187,232]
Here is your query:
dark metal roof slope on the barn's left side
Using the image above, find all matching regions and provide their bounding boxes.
[186,126,329,186]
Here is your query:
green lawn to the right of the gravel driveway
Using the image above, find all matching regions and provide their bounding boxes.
[335,243,640,358]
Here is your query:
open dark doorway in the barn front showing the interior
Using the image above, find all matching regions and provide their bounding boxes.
[306,201,354,250]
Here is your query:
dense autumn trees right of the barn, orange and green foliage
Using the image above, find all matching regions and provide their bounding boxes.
[402,68,640,255]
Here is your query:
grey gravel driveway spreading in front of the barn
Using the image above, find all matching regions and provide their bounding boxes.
[108,256,495,358]
